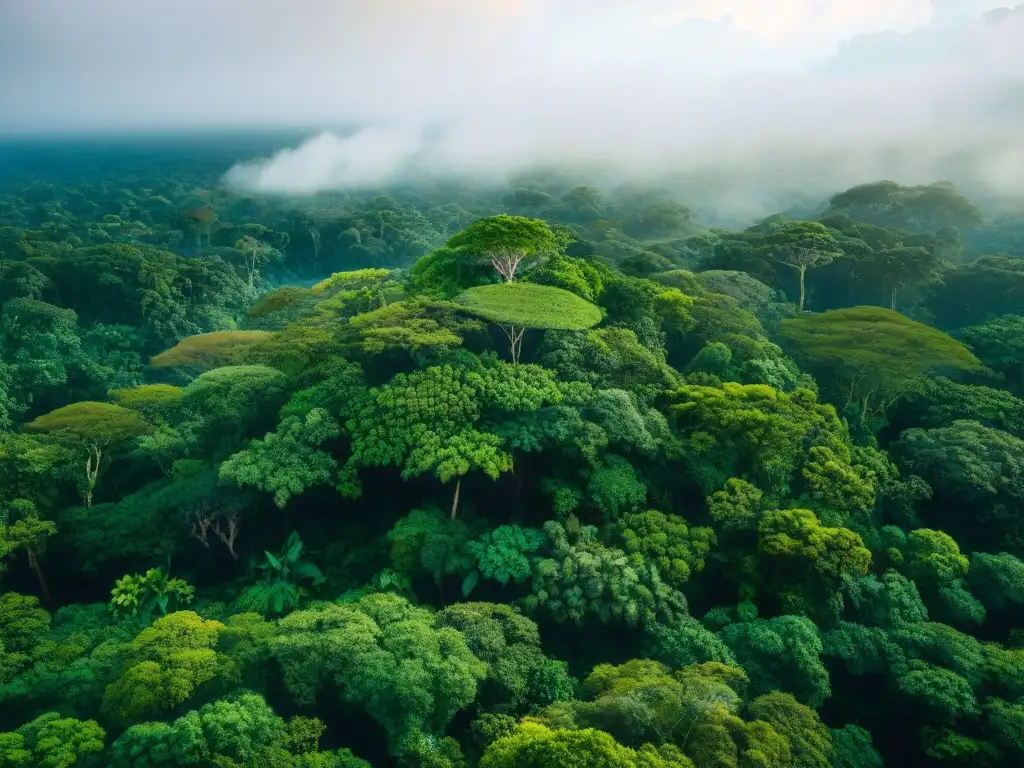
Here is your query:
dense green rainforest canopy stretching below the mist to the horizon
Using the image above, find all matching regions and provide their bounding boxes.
[0,136,1024,768]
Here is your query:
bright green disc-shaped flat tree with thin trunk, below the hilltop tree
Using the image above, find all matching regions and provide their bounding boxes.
[456,283,602,362]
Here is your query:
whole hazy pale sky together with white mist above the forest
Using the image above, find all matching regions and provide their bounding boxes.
[0,0,1024,214]
